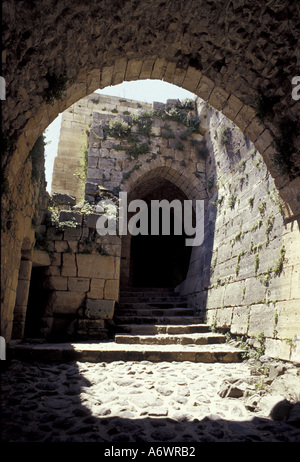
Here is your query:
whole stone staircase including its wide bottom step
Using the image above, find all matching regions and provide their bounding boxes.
[8,288,243,363]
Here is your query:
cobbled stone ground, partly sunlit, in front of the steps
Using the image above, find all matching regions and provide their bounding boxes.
[1,360,300,443]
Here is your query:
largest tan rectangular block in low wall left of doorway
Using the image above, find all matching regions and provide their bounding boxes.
[77,254,115,279]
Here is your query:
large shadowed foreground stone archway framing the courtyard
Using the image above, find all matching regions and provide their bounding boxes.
[2,0,300,338]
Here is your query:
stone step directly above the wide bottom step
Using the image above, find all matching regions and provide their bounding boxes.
[115,333,226,345]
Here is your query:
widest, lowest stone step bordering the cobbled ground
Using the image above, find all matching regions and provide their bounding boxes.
[7,341,244,363]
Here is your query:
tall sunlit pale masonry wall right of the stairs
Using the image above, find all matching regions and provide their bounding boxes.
[182,103,300,361]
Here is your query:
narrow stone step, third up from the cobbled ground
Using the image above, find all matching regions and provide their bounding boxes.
[113,324,209,335]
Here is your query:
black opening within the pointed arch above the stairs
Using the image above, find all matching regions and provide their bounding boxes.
[130,180,192,288]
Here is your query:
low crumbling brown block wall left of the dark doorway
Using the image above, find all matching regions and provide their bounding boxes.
[34,195,121,341]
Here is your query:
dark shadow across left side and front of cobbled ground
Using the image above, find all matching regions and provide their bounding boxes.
[1,360,300,444]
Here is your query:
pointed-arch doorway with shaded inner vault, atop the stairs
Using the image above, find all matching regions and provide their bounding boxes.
[120,177,191,288]
